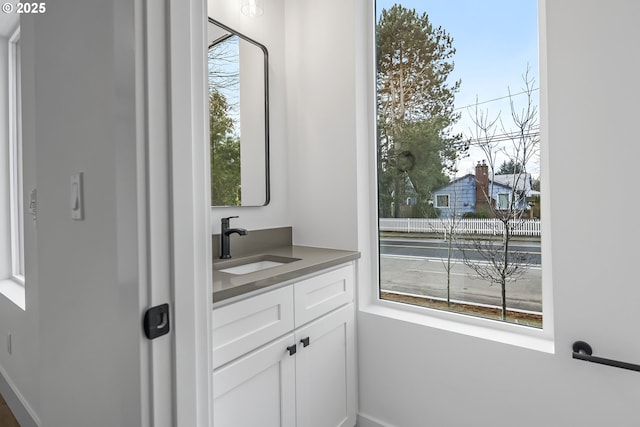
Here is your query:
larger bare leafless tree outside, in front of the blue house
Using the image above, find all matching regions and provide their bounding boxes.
[460,67,539,321]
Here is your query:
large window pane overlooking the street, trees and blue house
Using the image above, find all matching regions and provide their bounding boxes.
[375,0,542,328]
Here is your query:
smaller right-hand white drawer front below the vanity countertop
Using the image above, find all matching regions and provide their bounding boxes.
[293,264,353,327]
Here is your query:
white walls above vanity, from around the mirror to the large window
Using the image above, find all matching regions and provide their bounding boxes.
[208,0,359,249]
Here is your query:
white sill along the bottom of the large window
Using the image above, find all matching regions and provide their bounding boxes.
[360,300,555,354]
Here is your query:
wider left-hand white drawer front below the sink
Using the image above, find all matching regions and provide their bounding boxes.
[212,285,294,369]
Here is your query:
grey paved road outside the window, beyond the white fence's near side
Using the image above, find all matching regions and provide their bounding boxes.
[380,239,542,312]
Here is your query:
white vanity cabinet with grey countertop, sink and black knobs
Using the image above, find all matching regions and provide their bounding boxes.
[212,234,359,427]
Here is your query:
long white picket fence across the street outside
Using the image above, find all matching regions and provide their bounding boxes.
[380,218,540,237]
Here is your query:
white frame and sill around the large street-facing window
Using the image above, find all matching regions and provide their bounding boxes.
[360,0,555,353]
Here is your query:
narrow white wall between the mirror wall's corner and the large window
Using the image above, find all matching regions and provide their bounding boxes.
[286,0,358,249]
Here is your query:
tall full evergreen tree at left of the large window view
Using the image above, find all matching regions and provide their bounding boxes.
[376,5,465,221]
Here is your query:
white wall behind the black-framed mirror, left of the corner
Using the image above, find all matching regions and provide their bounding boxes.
[208,0,292,234]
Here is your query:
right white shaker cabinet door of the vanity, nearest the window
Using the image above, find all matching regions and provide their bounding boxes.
[296,304,356,427]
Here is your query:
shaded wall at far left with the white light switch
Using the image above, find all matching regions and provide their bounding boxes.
[0,0,143,427]
